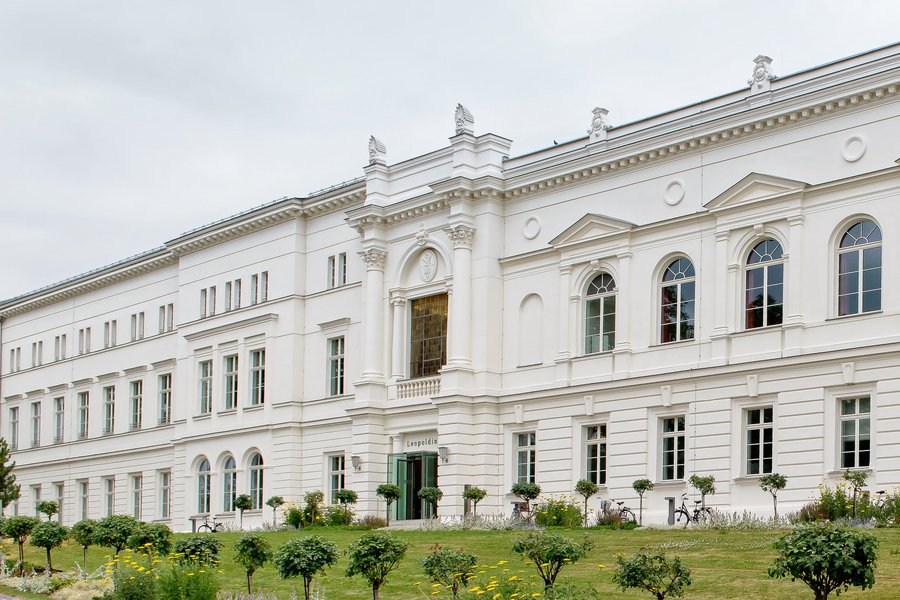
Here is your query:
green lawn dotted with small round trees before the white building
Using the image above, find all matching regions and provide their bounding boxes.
[2,528,900,600]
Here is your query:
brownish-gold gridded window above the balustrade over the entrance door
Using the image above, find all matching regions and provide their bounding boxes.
[409,294,447,378]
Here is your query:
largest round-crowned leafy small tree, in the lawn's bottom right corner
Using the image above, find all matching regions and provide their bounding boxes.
[769,521,878,600]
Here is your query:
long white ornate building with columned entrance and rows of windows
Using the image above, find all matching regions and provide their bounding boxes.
[0,45,900,529]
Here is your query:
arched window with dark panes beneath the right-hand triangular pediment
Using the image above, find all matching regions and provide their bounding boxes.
[744,239,784,329]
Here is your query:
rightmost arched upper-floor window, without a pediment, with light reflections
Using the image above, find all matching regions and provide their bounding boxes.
[838,221,881,316]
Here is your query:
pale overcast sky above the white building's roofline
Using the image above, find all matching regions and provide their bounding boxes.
[0,0,900,298]
